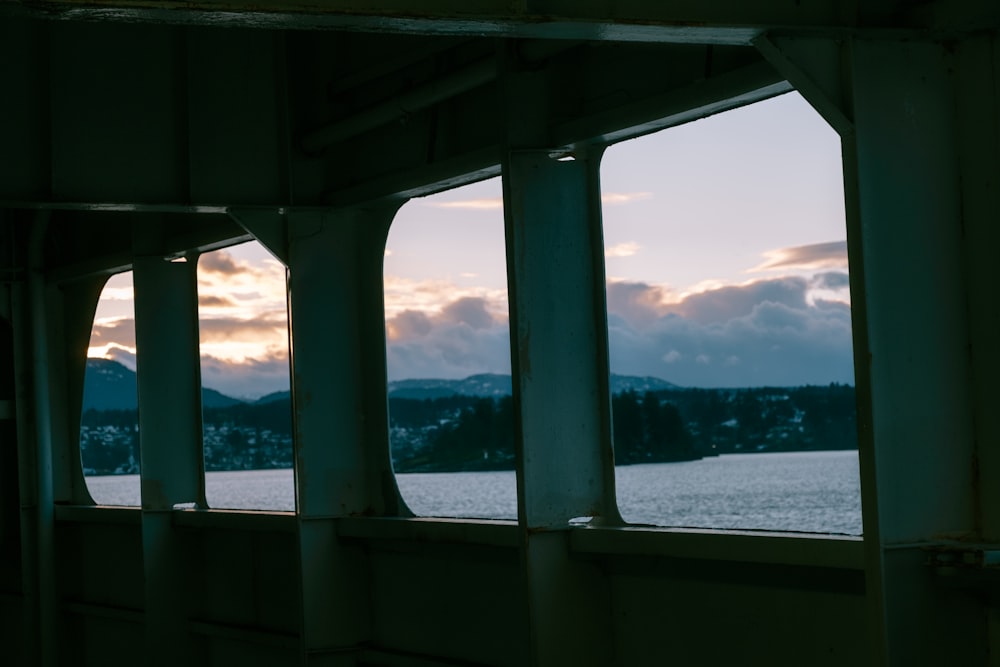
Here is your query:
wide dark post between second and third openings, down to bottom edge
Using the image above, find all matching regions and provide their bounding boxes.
[288,204,408,667]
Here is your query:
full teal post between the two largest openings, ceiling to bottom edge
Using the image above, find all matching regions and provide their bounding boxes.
[502,53,621,666]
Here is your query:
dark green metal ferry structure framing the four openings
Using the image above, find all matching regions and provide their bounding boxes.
[0,0,1000,667]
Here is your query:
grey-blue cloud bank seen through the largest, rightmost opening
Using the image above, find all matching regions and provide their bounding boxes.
[608,277,854,387]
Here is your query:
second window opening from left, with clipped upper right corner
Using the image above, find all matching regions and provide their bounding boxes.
[198,241,295,511]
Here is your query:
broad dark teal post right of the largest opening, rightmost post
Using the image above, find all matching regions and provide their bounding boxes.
[852,40,986,665]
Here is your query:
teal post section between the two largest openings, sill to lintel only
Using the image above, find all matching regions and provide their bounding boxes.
[504,151,621,529]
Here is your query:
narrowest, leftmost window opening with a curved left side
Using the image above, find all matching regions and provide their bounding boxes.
[80,271,140,506]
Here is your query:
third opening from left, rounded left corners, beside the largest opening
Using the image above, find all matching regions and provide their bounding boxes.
[384,179,517,519]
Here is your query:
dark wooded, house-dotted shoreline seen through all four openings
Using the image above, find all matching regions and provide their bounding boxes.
[81,384,857,474]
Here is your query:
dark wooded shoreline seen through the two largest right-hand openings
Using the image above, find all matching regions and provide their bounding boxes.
[389,384,857,472]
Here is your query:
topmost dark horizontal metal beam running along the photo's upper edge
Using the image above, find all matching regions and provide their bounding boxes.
[3,0,854,44]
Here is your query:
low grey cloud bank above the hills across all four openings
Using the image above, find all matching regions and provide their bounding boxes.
[86,272,854,395]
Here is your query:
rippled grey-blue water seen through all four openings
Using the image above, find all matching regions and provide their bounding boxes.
[87,451,861,535]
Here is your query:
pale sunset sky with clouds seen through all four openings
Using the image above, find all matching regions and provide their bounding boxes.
[91,93,854,397]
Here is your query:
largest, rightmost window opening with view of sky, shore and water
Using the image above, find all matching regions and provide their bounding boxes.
[601,93,861,534]
